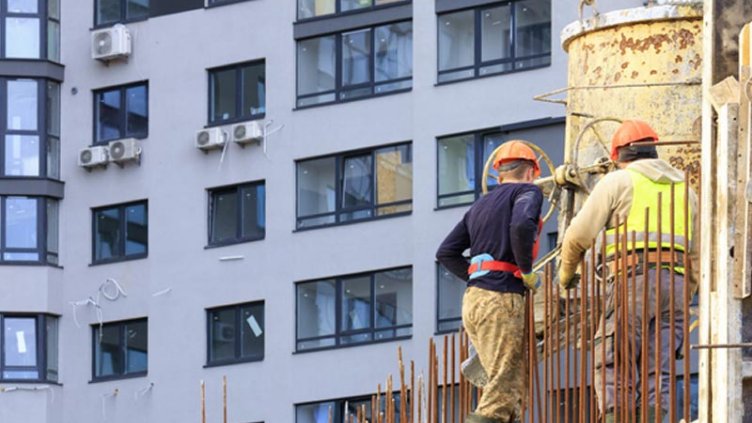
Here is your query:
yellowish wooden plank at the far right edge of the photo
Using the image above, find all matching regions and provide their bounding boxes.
[734,24,752,298]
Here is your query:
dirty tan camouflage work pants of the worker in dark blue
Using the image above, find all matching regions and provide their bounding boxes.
[462,287,526,422]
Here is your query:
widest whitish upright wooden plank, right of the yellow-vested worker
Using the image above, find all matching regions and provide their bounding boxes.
[711,103,744,422]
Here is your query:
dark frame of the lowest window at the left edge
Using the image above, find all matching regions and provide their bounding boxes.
[0,313,60,384]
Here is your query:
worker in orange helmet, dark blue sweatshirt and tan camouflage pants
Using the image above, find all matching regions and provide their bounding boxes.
[436,141,543,423]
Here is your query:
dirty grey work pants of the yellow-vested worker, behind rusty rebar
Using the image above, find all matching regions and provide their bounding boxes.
[594,269,684,415]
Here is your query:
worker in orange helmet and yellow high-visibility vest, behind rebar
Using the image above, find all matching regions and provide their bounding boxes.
[558,120,699,423]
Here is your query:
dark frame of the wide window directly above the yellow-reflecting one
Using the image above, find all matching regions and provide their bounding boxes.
[295,19,415,110]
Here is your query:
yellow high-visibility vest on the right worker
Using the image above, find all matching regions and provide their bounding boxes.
[606,169,692,273]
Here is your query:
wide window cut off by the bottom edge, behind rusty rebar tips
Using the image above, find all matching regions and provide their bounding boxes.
[295,392,402,423]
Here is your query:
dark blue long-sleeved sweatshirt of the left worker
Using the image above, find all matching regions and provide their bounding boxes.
[436,183,543,294]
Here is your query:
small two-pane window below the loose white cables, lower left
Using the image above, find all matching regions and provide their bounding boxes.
[92,319,149,380]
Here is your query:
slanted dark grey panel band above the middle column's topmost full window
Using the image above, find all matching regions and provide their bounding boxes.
[293,3,413,40]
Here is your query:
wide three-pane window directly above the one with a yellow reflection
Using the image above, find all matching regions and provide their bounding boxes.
[298,22,413,107]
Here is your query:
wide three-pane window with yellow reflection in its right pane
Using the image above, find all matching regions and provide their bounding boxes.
[297,144,413,229]
